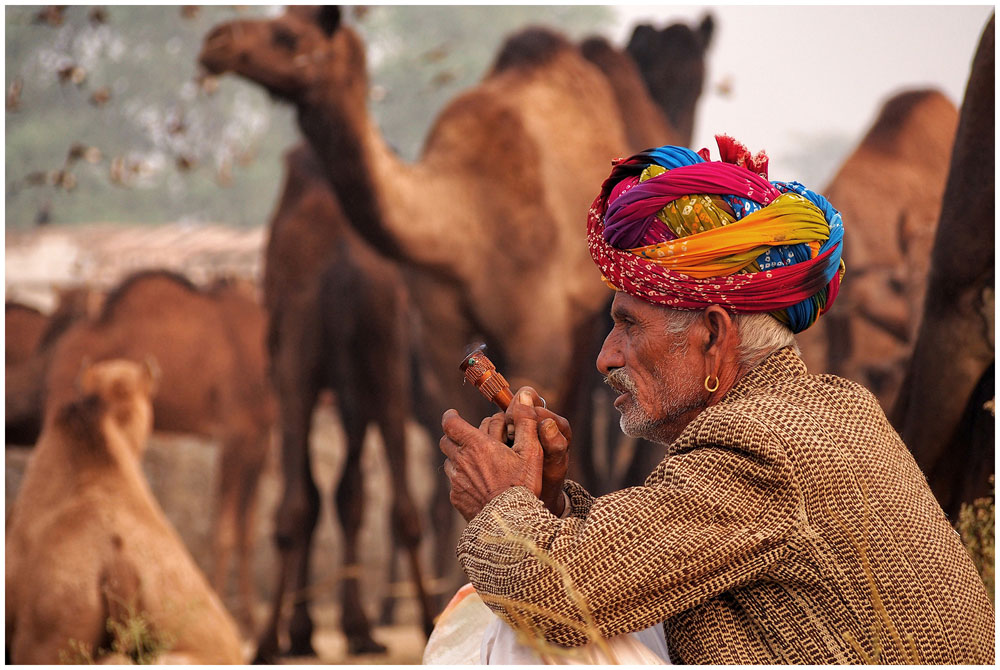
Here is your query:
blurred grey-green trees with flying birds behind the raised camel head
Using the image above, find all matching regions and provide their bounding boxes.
[5,5,614,227]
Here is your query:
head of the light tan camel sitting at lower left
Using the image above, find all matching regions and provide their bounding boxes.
[77,359,160,454]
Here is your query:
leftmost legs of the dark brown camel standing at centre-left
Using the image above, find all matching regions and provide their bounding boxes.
[254,384,319,664]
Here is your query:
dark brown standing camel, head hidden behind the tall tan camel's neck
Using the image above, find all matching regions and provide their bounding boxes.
[257,146,433,662]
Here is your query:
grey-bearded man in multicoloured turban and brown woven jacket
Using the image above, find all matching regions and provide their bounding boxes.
[440,137,994,664]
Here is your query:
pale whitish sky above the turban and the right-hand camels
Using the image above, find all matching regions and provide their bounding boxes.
[608,5,993,188]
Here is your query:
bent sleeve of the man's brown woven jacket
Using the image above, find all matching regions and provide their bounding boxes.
[458,406,803,646]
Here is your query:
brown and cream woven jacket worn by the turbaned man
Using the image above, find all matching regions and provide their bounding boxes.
[458,349,994,664]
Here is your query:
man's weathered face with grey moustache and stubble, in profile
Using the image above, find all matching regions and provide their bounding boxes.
[597,292,707,444]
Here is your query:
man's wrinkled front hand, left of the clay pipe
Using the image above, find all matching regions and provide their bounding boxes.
[439,397,544,521]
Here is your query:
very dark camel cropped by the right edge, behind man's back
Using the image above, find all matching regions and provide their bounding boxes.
[890,14,996,519]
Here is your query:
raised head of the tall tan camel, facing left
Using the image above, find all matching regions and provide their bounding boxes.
[198,6,368,104]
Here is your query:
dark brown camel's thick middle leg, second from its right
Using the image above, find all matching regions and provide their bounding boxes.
[336,414,385,655]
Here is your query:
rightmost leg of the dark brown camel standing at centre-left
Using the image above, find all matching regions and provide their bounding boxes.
[380,415,435,636]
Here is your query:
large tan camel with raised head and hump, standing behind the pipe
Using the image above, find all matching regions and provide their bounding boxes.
[199,8,712,660]
